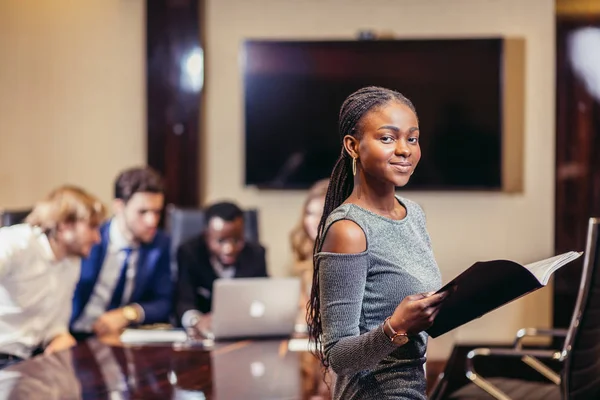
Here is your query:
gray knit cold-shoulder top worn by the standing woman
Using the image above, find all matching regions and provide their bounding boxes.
[315,197,441,400]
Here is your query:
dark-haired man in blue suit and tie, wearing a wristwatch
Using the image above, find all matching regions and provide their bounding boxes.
[70,167,173,338]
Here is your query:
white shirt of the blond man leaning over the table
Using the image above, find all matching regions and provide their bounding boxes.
[0,224,81,358]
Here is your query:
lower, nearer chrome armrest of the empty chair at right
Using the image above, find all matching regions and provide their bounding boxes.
[465,347,561,400]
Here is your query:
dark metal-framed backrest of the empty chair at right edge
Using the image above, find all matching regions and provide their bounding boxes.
[561,218,600,400]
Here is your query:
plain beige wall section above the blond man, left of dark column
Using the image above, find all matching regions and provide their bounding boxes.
[0,0,145,208]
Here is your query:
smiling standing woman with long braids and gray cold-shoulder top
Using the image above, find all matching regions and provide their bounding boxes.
[307,87,445,399]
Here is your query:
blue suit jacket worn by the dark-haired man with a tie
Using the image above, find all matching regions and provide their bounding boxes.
[70,222,173,326]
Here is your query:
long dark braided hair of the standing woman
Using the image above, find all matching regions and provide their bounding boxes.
[306,86,416,368]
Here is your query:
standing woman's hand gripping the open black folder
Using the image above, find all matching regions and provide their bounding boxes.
[390,292,448,334]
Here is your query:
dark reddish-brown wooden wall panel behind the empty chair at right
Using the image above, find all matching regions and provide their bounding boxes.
[554,16,600,327]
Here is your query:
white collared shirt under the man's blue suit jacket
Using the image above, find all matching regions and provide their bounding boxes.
[73,218,139,332]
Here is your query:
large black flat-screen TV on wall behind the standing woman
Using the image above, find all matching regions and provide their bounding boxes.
[242,38,503,190]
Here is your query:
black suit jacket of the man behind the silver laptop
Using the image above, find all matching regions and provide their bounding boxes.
[175,236,267,323]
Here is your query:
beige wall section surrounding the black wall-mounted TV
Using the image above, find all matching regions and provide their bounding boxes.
[203,0,555,358]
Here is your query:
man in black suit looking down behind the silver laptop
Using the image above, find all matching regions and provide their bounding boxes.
[176,202,267,321]
